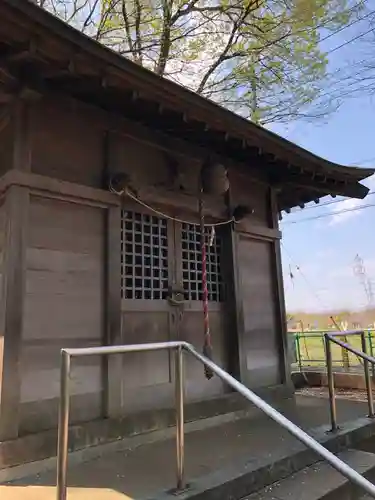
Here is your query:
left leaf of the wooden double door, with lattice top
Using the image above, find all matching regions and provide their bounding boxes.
[121,210,176,410]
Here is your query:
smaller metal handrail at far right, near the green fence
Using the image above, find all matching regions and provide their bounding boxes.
[324,330,375,432]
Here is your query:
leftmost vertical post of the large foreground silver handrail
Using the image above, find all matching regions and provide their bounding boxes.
[56,349,70,500]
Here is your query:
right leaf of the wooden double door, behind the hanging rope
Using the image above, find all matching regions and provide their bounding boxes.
[175,223,232,400]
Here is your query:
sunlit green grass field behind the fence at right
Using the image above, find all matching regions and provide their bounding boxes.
[289,332,375,367]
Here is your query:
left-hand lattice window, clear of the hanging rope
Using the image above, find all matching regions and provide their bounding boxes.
[121,210,168,300]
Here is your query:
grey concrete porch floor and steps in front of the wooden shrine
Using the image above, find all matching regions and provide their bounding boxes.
[0,398,375,500]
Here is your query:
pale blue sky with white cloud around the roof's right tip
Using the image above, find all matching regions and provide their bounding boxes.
[272,5,375,311]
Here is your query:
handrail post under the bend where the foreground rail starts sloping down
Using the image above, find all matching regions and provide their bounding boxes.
[175,346,185,490]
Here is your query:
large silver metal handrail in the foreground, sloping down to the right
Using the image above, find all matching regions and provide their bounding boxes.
[57,342,375,500]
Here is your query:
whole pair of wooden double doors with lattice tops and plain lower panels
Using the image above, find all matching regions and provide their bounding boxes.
[121,206,231,410]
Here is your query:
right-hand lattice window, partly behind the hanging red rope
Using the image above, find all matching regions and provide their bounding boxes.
[182,224,224,302]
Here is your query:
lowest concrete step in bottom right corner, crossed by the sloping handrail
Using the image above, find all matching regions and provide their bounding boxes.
[243,450,375,500]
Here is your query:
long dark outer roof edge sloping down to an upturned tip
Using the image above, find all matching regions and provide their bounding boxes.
[2,0,375,186]
